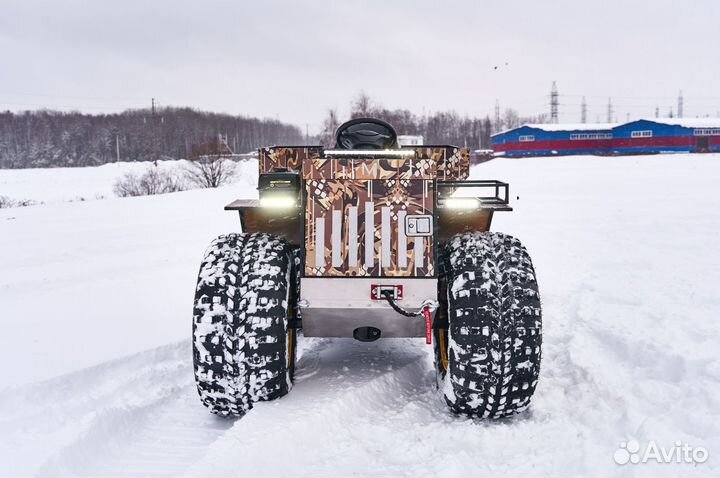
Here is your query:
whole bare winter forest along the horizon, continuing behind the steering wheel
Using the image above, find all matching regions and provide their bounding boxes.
[0,93,543,168]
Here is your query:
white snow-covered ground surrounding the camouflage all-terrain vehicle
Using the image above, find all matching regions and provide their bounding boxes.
[0,155,720,477]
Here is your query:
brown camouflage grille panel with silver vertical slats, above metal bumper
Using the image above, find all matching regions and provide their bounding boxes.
[305,179,435,277]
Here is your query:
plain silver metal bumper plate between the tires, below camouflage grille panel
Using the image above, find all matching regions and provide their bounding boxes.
[300,277,437,337]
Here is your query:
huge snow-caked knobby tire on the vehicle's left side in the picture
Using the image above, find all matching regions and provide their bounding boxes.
[193,234,296,416]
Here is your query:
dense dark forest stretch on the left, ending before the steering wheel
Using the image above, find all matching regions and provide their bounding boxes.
[0,108,305,168]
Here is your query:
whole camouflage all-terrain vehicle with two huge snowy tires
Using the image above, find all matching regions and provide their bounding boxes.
[193,118,542,418]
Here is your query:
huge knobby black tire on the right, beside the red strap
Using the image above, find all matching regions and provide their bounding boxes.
[435,232,542,418]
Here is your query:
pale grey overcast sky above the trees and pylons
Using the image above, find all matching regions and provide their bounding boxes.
[0,0,720,133]
